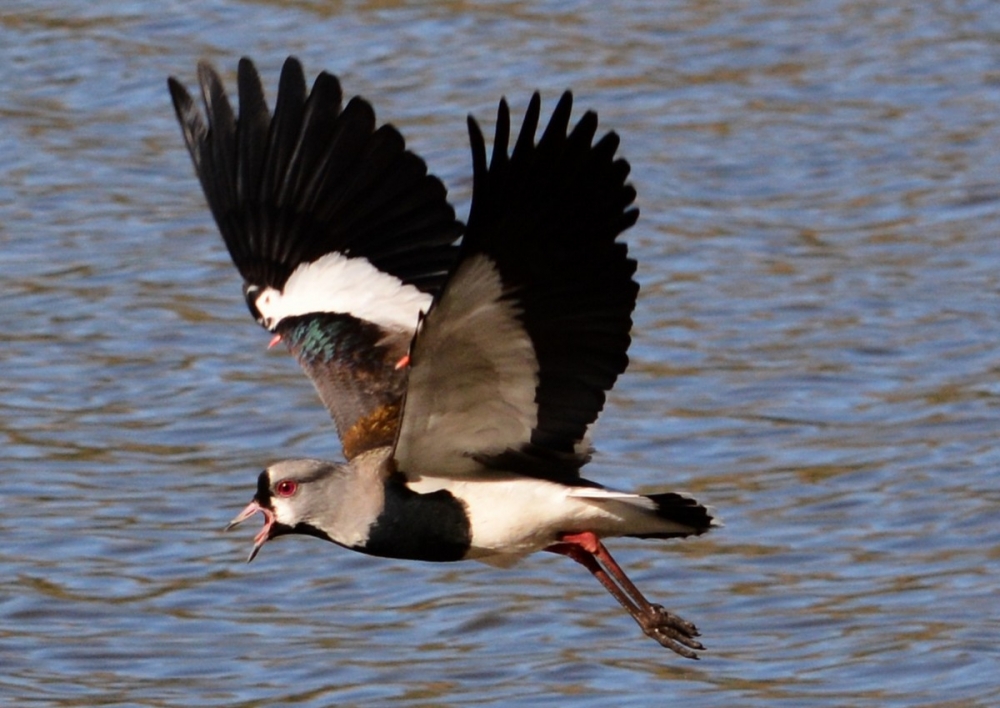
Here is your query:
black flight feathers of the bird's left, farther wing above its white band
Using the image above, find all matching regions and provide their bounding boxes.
[168,58,462,293]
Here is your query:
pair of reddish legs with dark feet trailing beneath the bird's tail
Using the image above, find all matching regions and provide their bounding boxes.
[545,531,705,659]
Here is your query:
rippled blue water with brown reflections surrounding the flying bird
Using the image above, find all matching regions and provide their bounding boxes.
[0,0,1000,707]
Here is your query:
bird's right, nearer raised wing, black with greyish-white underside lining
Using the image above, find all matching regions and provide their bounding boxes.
[395,92,638,481]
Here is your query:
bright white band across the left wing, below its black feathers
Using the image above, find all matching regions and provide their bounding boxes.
[256,252,432,332]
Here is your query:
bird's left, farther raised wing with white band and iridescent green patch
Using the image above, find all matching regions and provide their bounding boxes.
[168,58,462,457]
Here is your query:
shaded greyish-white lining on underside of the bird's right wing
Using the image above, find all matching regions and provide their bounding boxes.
[395,254,538,478]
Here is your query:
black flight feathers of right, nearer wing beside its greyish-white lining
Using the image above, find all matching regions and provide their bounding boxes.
[462,92,639,477]
